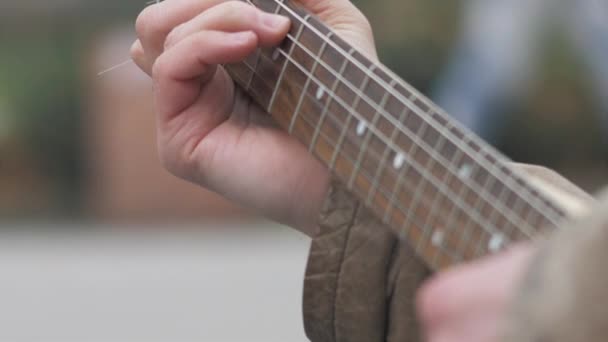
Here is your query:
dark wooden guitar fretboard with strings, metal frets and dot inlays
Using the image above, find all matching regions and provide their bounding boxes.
[225,0,565,269]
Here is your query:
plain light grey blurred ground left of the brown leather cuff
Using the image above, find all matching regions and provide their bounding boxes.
[0,223,309,342]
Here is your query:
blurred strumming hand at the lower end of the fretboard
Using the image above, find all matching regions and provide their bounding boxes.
[417,245,533,342]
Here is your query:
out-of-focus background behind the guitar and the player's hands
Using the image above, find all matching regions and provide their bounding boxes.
[0,0,608,341]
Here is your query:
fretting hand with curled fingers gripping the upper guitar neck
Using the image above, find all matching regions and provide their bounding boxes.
[131,0,375,235]
